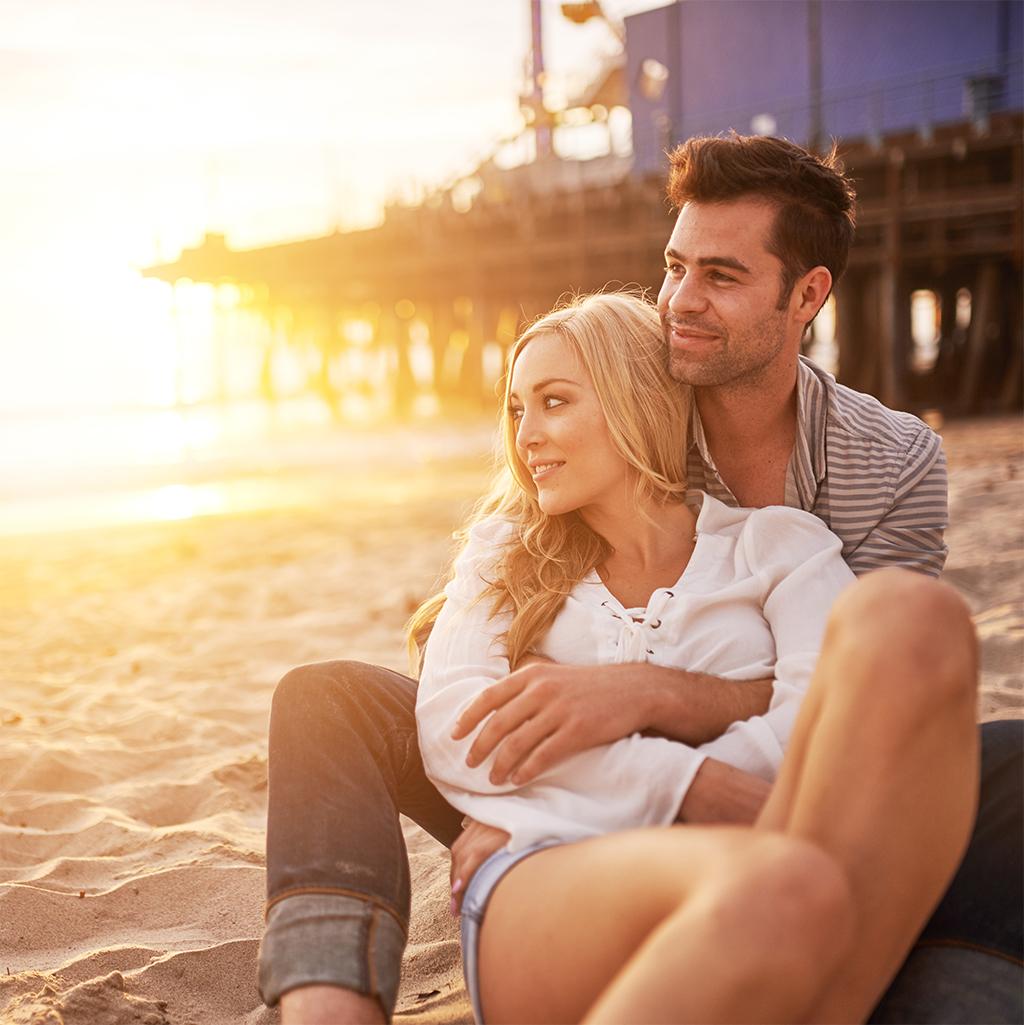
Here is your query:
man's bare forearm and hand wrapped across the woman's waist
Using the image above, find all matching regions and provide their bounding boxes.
[452,659,772,785]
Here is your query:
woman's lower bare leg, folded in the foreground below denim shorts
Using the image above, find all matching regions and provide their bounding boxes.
[480,826,852,1025]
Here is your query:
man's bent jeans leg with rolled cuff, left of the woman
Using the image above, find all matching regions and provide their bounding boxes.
[259,661,462,1016]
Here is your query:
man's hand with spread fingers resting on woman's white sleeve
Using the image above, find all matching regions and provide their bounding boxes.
[452,661,648,786]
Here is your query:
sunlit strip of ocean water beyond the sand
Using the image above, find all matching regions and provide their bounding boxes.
[0,399,494,536]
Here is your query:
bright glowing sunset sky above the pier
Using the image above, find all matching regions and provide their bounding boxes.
[0,0,660,413]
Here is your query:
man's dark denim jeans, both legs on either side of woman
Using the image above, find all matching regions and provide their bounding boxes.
[259,661,1024,1023]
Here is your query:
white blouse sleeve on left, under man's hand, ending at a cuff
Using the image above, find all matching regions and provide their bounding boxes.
[416,519,704,851]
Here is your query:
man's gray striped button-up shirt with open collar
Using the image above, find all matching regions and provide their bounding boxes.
[687,357,949,576]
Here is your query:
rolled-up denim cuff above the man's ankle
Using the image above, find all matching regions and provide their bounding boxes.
[259,894,406,1020]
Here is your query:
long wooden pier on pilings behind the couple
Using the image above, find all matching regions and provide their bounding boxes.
[144,113,1024,414]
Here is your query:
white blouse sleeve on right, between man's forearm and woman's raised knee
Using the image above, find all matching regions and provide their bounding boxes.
[698,506,855,780]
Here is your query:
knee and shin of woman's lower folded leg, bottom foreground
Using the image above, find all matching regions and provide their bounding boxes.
[585,830,855,1025]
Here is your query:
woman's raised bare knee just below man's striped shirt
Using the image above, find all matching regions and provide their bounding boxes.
[823,568,978,707]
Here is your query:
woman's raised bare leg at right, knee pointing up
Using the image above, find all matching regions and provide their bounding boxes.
[757,570,978,1022]
